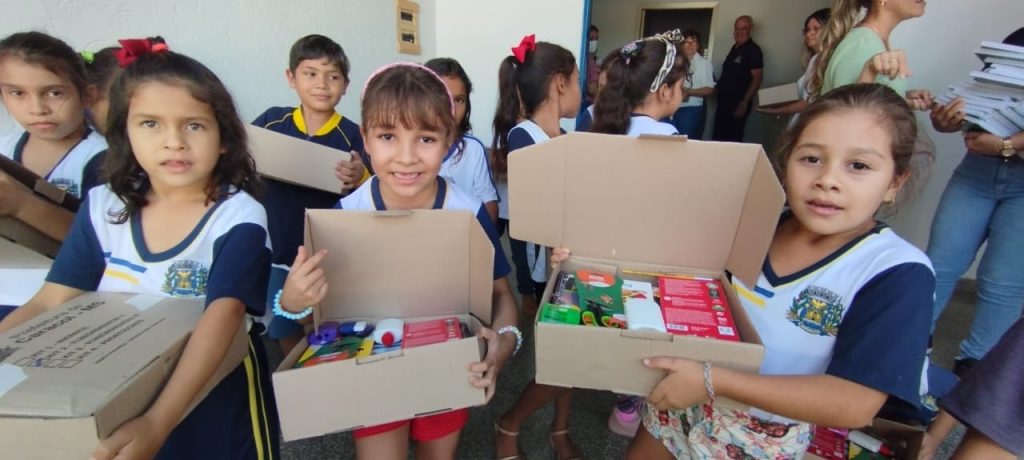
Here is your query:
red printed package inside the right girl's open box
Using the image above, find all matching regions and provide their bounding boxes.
[657,277,739,342]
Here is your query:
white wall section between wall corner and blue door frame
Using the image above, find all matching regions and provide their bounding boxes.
[435,0,584,144]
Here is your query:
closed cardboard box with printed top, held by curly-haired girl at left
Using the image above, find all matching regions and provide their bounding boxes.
[0,292,249,460]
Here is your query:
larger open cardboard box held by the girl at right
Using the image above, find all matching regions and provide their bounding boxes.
[509,133,784,405]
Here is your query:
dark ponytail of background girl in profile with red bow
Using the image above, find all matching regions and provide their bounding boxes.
[490,42,577,178]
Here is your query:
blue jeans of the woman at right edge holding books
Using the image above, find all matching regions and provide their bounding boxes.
[928,154,1024,360]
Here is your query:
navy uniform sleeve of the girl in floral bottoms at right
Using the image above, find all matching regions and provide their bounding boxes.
[825,263,935,408]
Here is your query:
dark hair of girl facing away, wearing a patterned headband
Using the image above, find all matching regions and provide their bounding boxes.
[590,39,689,134]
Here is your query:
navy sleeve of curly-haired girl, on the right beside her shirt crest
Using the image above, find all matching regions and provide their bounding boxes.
[206,223,270,317]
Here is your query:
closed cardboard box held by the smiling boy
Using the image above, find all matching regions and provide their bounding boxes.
[246,125,352,194]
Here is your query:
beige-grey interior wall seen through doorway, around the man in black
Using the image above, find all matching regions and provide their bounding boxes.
[591,0,831,150]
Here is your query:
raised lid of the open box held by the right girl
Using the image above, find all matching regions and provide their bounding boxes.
[508,133,783,281]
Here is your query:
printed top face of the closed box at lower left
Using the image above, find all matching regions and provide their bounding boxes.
[0,293,203,417]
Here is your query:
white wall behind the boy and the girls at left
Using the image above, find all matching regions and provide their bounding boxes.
[0,0,436,132]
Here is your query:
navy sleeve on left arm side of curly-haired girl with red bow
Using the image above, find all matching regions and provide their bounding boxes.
[46,198,104,291]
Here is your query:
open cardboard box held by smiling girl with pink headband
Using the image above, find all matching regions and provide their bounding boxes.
[273,210,495,441]
